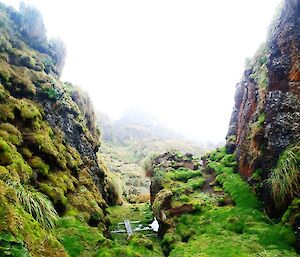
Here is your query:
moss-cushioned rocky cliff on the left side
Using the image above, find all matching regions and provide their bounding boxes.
[0,4,113,256]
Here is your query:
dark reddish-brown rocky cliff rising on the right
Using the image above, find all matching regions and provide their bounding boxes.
[227,0,300,211]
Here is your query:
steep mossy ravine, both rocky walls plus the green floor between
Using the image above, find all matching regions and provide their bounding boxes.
[0,0,300,257]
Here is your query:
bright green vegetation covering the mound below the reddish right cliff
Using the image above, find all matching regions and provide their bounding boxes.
[153,148,299,257]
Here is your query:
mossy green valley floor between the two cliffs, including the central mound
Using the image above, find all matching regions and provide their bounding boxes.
[55,149,298,257]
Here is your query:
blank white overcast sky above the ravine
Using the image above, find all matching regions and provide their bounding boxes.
[0,0,281,141]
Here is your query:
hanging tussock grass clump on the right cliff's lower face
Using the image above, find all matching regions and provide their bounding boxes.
[268,145,300,206]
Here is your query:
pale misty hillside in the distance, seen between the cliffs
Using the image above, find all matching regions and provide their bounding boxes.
[97,110,204,199]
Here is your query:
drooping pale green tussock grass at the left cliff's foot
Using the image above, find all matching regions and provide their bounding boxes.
[5,180,58,229]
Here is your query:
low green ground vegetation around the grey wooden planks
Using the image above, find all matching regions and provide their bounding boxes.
[54,204,163,257]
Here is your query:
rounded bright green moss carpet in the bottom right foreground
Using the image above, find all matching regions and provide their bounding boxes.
[163,204,297,257]
